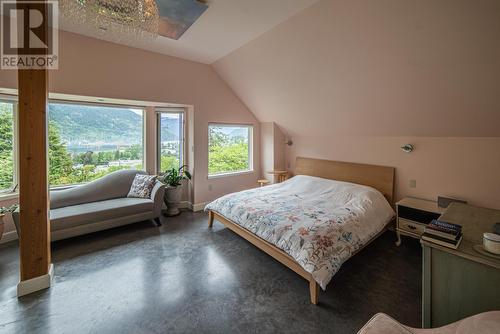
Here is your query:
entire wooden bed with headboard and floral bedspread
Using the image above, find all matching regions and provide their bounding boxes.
[205,157,394,304]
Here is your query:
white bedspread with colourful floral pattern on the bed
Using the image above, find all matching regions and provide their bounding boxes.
[205,175,394,289]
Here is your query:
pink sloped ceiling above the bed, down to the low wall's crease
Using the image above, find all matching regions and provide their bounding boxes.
[214,0,500,137]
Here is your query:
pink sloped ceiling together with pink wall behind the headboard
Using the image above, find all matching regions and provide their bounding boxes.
[214,0,500,209]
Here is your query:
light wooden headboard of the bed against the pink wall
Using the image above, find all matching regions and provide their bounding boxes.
[295,157,395,205]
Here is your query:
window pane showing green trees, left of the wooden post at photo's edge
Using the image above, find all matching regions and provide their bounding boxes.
[0,100,16,192]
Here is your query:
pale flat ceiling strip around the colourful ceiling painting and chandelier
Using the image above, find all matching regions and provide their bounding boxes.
[59,0,318,64]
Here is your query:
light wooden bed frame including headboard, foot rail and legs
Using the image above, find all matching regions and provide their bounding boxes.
[208,157,395,305]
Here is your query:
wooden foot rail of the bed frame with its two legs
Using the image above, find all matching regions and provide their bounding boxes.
[208,210,319,305]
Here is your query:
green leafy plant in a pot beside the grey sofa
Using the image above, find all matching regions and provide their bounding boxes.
[160,165,191,216]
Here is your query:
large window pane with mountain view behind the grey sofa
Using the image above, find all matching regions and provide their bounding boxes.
[48,102,144,186]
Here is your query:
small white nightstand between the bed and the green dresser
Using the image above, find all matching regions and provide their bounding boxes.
[396,197,445,246]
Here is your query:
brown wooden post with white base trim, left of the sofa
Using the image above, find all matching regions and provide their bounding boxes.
[18,0,52,296]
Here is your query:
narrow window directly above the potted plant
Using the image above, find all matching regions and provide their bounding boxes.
[157,109,184,172]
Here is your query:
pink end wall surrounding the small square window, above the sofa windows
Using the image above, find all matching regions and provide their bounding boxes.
[0,32,260,222]
